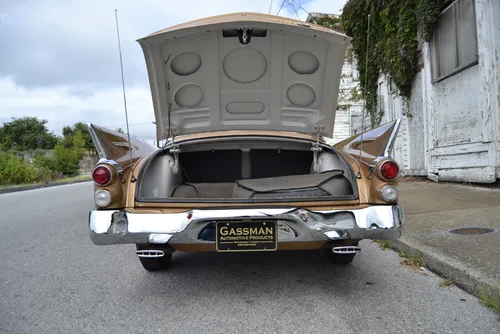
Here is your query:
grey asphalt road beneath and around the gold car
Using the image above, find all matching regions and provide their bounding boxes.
[0,183,500,334]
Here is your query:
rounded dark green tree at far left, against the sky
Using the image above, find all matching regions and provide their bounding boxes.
[0,117,58,151]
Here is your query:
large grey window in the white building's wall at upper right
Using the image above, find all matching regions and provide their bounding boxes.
[432,0,478,81]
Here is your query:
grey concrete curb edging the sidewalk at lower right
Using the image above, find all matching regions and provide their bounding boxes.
[392,236,500,298]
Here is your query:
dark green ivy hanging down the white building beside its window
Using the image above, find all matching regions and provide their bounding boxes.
[317,0,440,126]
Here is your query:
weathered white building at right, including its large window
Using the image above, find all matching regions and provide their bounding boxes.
[379,0,500,183]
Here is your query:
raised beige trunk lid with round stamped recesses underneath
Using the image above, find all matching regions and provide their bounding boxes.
[138,13,350,140]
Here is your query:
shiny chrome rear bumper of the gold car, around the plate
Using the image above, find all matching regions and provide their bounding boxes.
[89,205,404,245]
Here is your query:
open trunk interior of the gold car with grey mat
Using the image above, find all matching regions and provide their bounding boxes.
[137,139,356,202]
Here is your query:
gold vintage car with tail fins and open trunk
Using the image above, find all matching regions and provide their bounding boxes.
[89,13,403,271]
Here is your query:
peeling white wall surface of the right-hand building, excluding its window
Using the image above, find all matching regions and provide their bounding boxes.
[379,0,500,183]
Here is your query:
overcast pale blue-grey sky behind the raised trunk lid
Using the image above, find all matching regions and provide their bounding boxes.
[0,0,346,142]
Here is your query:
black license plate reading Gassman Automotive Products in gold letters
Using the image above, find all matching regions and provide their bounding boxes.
[215,220,278,252]
